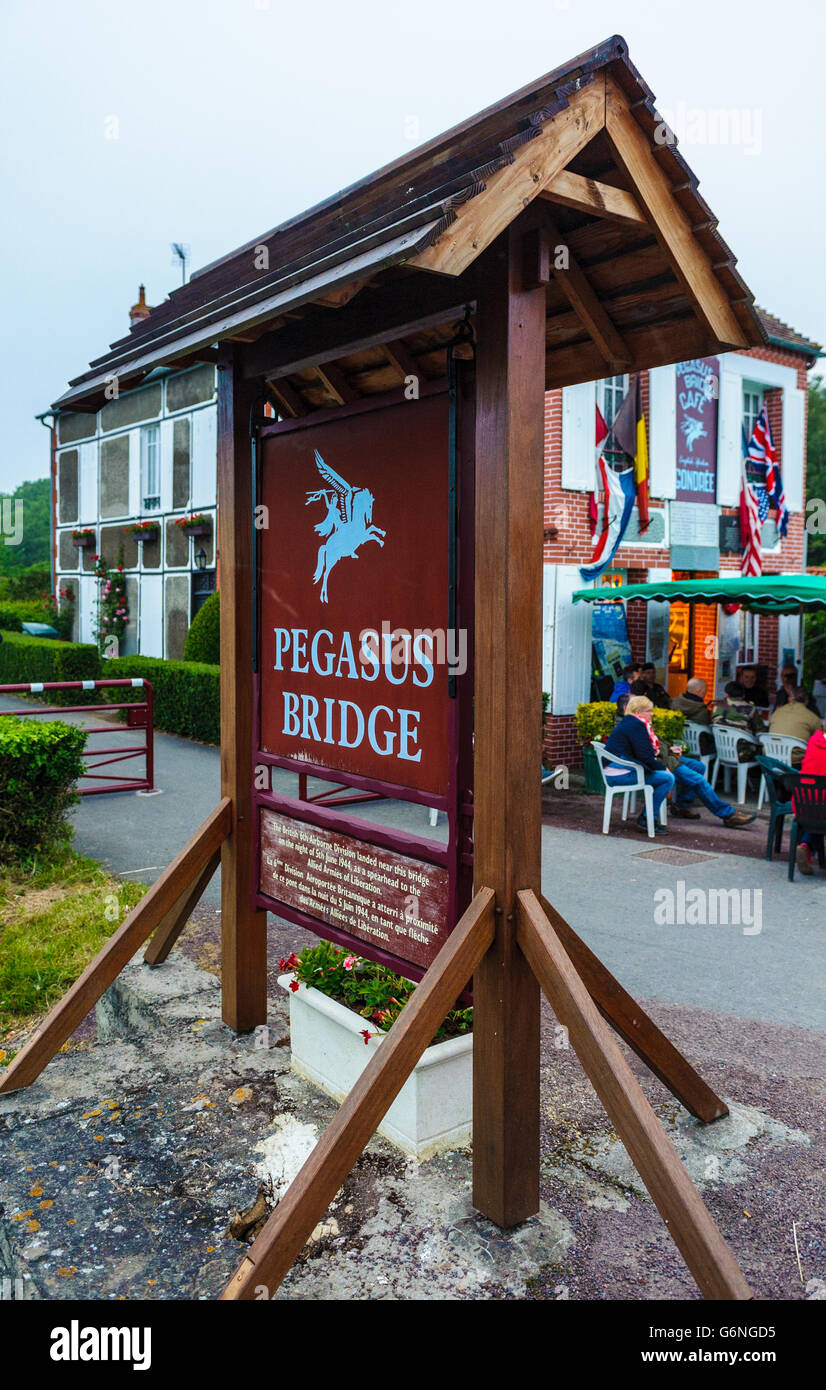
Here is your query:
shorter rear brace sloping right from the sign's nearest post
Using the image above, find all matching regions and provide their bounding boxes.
[540,895,729,1125]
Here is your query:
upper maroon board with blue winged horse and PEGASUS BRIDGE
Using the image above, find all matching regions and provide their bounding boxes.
[260,393,449,796]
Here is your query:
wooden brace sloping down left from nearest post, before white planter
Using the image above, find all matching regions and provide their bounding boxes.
[221,888,494,1300]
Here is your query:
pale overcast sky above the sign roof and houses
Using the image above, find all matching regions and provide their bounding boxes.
[0,0,826,488]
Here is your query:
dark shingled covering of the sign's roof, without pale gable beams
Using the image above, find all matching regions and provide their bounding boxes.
[56,36,768,410]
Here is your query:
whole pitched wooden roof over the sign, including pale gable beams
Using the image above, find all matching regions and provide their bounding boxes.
[56,36,768,416]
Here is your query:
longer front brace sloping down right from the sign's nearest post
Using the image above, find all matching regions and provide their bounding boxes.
[517,891,751,1298]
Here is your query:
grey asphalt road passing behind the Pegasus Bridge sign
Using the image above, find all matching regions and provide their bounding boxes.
[0,698,826,1031]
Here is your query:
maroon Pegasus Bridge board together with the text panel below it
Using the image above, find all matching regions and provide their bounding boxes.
[253,389,473,977]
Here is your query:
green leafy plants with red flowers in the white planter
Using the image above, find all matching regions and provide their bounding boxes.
[281,941,473,1043]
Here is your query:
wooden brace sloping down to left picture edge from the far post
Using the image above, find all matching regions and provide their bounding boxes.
[0,798,232,1094]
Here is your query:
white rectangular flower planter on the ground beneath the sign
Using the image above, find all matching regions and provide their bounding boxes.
[278,974,473,1159]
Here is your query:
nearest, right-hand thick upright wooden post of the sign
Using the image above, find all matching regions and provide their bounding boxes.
[473,218,545,1227]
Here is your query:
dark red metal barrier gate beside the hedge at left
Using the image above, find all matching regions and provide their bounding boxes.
[0,677,156,796]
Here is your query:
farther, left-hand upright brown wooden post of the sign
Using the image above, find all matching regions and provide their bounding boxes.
[218,353,267,1033]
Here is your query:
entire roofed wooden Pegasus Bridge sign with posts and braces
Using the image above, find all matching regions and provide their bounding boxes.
[6,38,795,1298]
